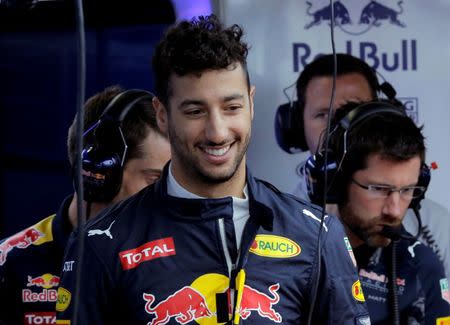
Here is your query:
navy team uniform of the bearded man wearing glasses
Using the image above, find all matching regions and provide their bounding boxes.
[354,234,450,325]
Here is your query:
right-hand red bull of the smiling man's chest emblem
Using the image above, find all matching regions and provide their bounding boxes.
[239,283,283,323]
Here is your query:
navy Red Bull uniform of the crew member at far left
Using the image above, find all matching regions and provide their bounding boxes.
[0,196,72,325]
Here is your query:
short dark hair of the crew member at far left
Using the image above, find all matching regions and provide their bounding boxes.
[67,86,167,166]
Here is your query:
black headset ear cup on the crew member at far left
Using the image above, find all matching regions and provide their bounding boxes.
[75,146,123,202]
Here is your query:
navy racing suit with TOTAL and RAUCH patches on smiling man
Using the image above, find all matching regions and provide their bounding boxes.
[56,167,369,325]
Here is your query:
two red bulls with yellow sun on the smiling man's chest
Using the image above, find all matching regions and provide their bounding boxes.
[142,273,282,325]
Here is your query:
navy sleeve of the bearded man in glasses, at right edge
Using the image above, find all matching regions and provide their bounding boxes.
[416,242,450,324]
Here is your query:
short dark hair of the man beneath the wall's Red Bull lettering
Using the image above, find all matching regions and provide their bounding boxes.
[296,53,380,119]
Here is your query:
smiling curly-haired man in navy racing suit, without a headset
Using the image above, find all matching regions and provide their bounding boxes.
[56,16,368,325]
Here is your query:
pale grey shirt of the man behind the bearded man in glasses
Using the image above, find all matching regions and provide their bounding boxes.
[292,161,450,281]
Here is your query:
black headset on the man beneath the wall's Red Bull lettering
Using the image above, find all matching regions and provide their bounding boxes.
[274,57,397,154]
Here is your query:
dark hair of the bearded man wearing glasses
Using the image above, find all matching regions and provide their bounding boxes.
[328,100,426,191]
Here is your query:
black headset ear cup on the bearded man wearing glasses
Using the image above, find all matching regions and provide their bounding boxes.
[305,151,344,206]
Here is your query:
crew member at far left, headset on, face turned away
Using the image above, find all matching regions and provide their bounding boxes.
[0,86,170,325]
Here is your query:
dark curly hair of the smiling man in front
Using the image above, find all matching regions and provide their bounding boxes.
[153,15,250,107]
